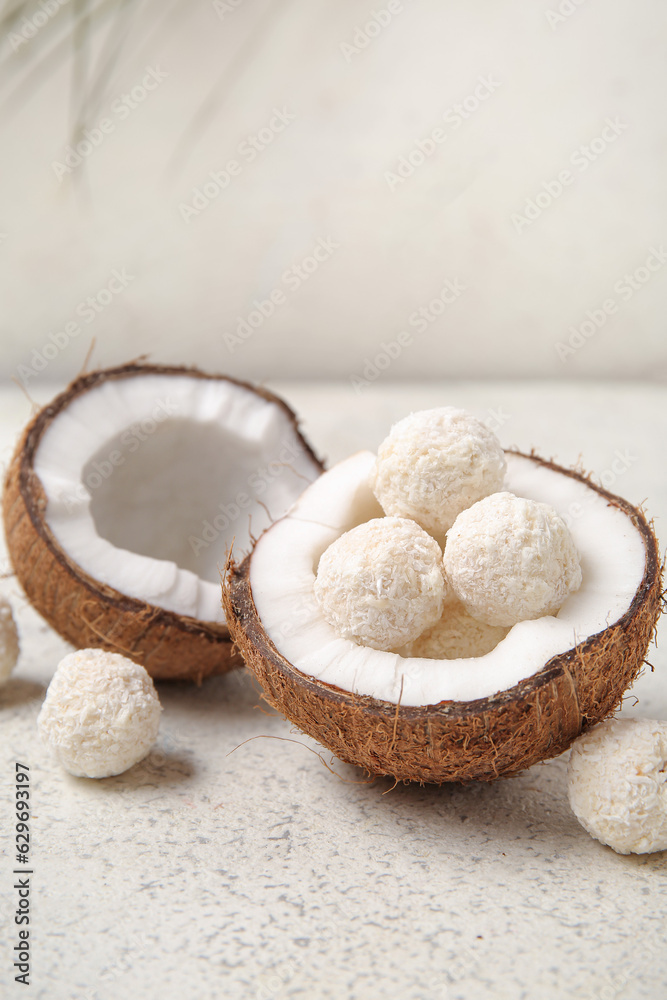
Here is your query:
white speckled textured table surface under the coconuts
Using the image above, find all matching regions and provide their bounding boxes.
[0,381,667,1000]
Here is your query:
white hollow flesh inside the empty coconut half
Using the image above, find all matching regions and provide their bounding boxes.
[34,374,321,622]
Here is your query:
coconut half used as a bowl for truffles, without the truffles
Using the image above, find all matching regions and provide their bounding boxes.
[224,452,661,782]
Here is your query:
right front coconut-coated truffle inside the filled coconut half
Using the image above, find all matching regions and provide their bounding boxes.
[444,493,581,625]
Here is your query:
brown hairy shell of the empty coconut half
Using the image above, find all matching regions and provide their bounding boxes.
[3,363,323,683]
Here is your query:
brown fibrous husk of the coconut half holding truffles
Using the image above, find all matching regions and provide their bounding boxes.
[223,452,662,783]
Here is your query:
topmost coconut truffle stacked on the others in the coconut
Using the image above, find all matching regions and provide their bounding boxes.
[370,406,506,541]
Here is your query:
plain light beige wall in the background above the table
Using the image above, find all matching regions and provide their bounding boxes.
[0,0,667,388]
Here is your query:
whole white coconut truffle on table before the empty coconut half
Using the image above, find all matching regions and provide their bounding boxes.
[37,649,162,778]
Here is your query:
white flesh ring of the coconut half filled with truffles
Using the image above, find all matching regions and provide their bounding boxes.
[250,452,646,706]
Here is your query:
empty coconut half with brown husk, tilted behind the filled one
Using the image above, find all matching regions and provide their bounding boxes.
[3,364,322,680]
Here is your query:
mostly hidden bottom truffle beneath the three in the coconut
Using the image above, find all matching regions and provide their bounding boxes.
[398,599,509,660]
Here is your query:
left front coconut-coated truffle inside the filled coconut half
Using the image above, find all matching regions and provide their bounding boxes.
[314,517,446,650]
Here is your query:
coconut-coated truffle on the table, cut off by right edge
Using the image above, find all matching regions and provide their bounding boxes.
[568,719,667,854]
